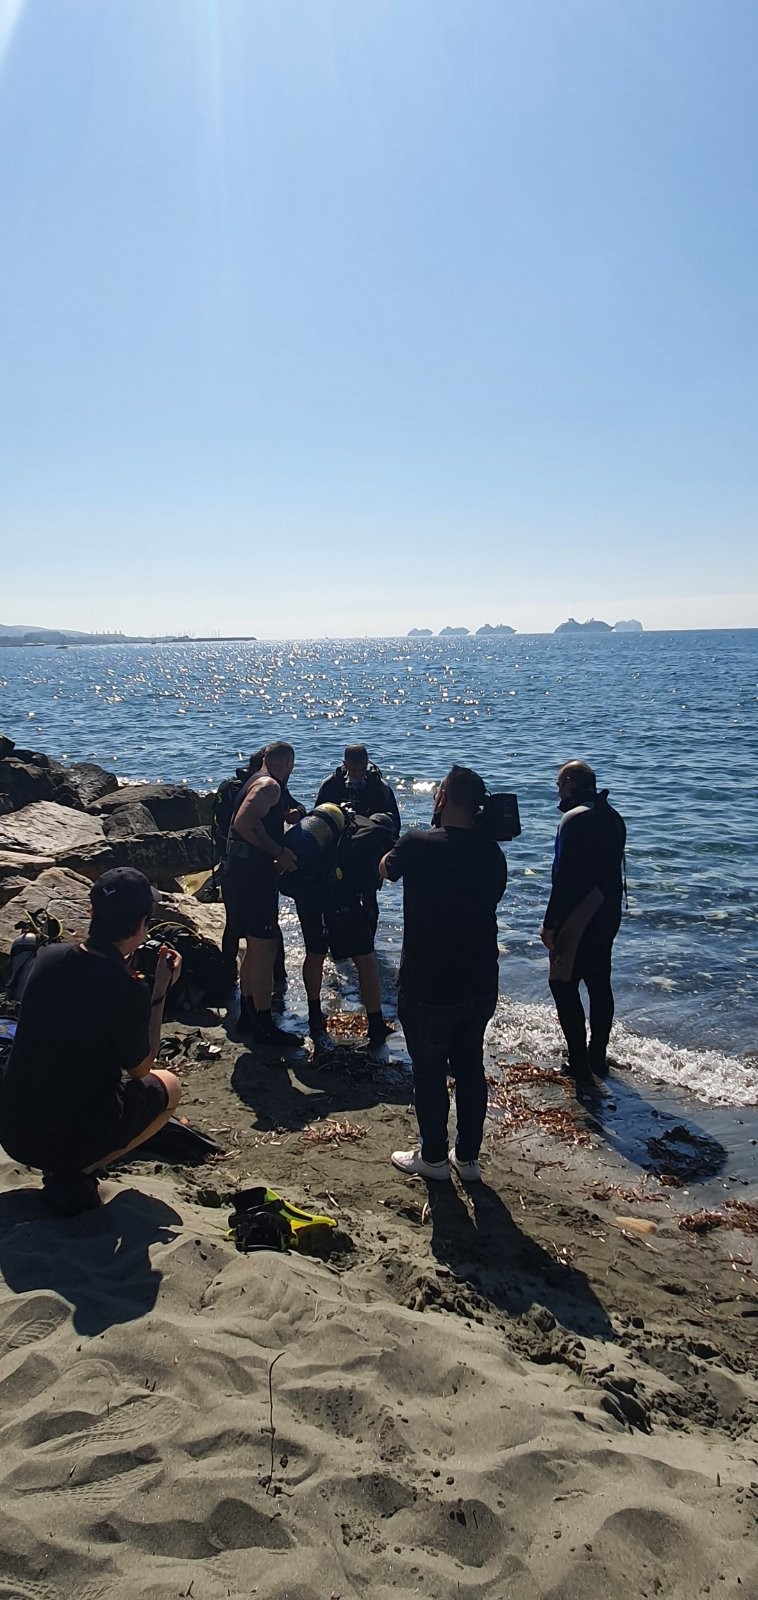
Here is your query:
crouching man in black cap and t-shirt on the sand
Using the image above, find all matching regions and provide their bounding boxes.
[0,867,181,1216]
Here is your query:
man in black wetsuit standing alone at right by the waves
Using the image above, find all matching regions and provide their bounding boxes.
[541,762,627,1080]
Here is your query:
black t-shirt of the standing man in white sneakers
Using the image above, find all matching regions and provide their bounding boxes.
[385,827,507,1005]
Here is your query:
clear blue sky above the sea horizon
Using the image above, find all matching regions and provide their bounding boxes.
[0,0,758,637]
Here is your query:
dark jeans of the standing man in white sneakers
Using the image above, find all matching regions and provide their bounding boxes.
[398,995,496,1162]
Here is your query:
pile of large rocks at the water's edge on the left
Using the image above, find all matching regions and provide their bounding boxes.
[0,738,215,968]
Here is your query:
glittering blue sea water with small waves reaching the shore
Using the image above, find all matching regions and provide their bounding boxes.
[0,630,758,1104]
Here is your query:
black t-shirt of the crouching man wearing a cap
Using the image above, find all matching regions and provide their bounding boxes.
[0,944,150,1166]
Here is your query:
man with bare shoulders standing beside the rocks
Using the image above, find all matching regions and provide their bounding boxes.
[222,741,302,1050]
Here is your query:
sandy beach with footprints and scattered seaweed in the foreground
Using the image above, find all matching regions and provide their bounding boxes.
[0,979,758,1600]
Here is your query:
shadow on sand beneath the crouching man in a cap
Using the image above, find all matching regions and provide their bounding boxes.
[0,1189,182,1334]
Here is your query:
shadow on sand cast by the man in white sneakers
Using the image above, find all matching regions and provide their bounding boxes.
[427,1182,614,1339]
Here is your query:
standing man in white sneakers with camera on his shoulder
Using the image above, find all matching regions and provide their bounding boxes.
[379,766,507,1182]
